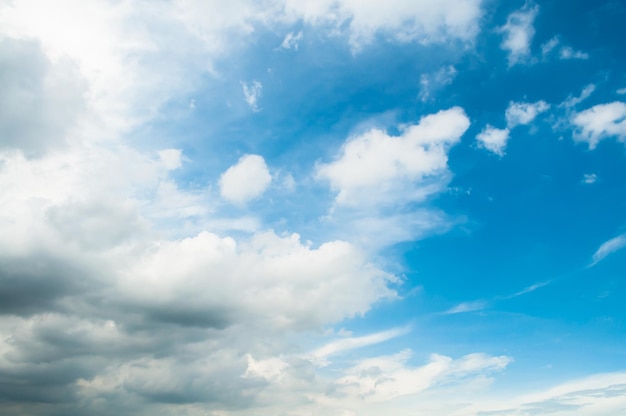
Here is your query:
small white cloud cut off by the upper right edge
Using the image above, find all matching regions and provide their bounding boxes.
[571,101,626,149]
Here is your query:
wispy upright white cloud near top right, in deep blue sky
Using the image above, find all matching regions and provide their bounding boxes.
[498,2,539,67]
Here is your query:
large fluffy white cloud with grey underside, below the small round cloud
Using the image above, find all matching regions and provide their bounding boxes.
[119,232,395,331]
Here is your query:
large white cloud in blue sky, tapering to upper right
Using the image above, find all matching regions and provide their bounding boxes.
[317,107,469,206]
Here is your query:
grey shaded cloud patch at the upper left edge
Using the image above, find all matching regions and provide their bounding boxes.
[0,37,87,156]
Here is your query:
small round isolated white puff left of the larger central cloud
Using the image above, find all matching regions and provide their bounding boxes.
[219,155,272,204]
